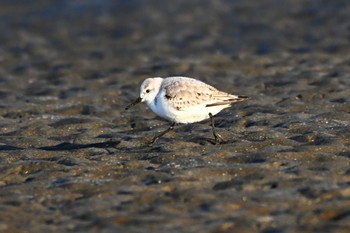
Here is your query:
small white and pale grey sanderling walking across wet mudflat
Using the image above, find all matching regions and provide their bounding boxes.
[125,77,248,144]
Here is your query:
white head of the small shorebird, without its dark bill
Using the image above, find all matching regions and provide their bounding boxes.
[140,77,163,104]
